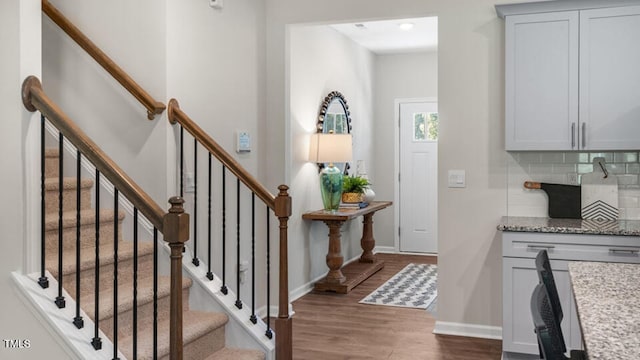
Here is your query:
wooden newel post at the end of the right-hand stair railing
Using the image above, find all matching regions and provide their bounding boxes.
[275,185,293,360]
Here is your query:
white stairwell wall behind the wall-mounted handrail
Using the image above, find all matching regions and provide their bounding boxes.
[42,0,170,204]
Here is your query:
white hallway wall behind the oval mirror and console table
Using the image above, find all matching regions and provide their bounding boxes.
[285,25,374,291]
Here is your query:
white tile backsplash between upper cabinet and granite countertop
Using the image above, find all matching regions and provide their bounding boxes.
[507,151,640,220]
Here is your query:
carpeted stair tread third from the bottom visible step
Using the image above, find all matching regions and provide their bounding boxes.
[80,275,192,320]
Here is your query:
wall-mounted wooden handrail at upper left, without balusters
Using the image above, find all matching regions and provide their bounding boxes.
[42,0,166,120]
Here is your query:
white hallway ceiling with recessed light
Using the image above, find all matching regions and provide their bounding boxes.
[330,17,438,54]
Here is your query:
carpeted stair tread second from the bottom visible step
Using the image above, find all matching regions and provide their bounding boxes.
[118,310,230,360]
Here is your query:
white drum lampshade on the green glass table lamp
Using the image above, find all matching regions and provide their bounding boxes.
[309,133,352,163]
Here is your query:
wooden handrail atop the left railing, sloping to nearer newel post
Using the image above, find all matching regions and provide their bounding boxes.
[22,76,165,232]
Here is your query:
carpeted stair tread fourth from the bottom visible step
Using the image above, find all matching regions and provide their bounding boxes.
[47,241,153,278]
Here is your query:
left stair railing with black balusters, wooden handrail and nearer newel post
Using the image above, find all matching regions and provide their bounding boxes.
[22,76,189,360]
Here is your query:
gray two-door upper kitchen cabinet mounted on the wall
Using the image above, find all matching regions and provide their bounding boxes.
[505,1,640,151]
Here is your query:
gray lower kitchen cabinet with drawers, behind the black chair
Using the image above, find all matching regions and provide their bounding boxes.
[502,231,640,360]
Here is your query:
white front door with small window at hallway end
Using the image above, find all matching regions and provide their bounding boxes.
[399,101,438,253]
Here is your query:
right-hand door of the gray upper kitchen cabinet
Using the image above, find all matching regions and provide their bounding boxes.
[580,6,640,150]
